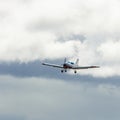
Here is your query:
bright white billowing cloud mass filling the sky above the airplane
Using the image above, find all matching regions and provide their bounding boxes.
[0,0,120,76]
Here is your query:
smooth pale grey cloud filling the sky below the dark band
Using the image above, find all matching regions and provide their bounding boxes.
[0,76,120,120]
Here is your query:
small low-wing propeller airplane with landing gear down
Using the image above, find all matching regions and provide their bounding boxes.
[42,58,100,73]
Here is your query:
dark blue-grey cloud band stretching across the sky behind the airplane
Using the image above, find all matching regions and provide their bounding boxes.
[0,60,120,85]
